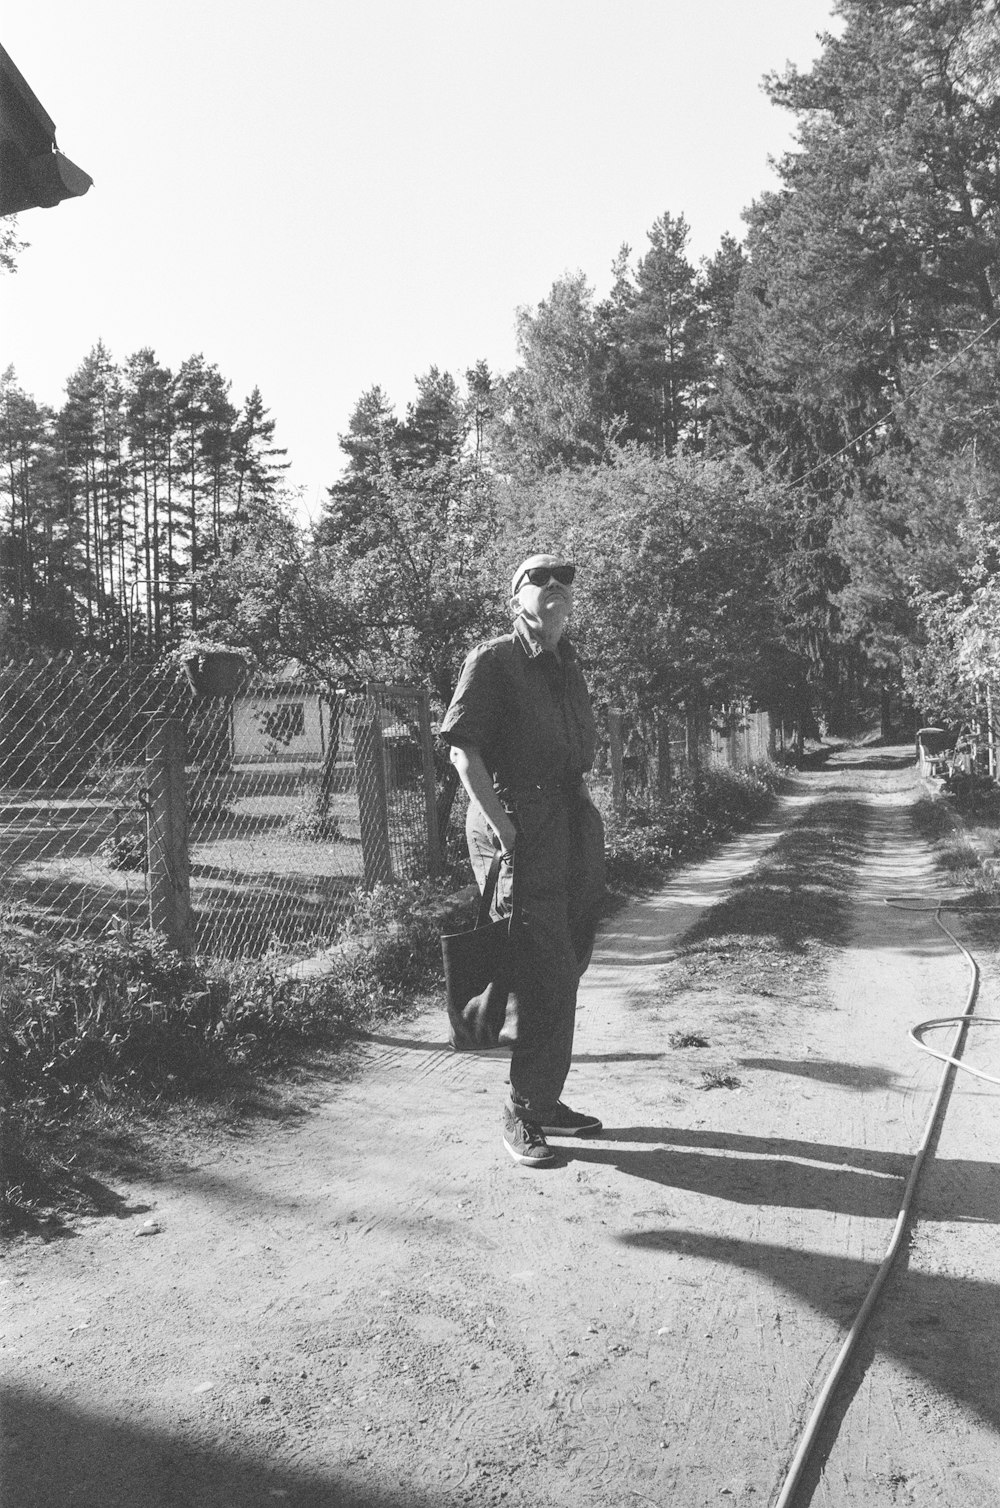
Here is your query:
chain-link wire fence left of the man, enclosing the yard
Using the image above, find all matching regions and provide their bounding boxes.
[0,656,439,958]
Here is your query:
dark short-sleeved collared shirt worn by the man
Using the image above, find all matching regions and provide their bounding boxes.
[440,623,597,789]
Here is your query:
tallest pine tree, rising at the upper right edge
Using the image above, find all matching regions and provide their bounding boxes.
[721,0,1000,723]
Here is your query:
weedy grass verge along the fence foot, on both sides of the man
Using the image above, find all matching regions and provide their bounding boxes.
[0,768,780,1231]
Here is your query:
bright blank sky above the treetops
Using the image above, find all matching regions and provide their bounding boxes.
[0,0,833,511]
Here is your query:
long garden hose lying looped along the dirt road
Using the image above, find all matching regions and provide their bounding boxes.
[774,896,1000,1508]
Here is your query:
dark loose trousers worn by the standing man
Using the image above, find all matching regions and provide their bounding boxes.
[466,792,603,1120]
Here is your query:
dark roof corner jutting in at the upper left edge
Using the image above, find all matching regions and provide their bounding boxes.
[0,47,94,216]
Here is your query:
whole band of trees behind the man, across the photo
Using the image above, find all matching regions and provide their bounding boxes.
[7,0,1000,747]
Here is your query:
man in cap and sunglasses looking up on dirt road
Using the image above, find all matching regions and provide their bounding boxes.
[440,555,603,1167]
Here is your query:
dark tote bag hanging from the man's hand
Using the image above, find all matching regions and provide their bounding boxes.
[440,854,520,1051]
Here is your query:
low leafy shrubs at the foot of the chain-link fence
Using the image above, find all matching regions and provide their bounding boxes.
[0,881,452,1102]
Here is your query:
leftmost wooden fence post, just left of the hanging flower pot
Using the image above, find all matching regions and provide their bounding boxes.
[146,716,195,958]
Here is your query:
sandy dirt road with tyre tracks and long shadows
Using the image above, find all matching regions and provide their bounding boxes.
[3,751,1000,1508]
